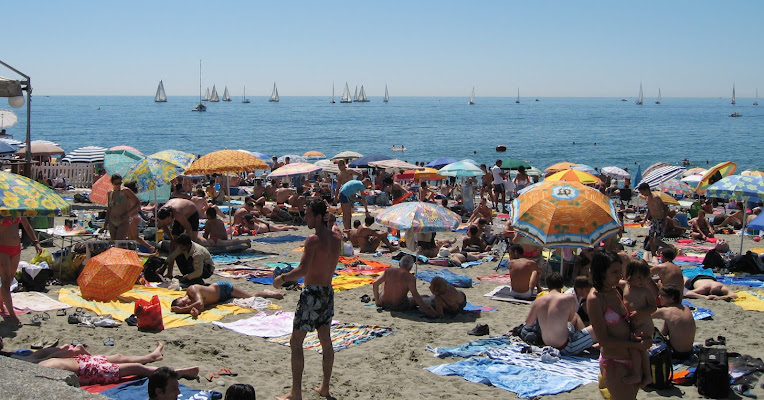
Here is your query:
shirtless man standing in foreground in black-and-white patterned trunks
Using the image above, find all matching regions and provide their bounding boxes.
[273,200,342,400]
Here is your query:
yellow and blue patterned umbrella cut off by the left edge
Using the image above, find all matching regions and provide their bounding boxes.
[0,171,71,217]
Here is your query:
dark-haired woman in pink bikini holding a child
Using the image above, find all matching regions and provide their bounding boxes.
[586,250,652,400]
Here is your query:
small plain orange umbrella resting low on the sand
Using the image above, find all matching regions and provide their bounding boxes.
[77,247,143,302]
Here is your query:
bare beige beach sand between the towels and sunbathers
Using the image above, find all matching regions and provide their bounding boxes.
[0,203,764,399]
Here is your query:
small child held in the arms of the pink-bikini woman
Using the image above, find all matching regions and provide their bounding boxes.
[621,260,657,387]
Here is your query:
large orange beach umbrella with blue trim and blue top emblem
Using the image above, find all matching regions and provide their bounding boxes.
[510,181,620,247]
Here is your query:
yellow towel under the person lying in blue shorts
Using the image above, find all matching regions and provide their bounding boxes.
[58,285,253,329]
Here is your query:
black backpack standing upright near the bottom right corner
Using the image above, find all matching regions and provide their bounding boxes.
[695,347,730,399]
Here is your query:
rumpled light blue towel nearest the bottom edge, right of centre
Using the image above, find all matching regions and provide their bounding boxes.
[427,358,586,399]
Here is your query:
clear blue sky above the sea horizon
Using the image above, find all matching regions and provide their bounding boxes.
[0,0,764,98]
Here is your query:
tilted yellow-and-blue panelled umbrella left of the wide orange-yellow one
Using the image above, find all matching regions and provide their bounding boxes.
[123,150,196,193]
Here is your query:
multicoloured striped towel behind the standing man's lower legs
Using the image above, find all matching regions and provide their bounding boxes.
[266,323,395,353]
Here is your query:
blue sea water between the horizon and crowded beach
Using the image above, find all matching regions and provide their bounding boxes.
[8,96,764,171]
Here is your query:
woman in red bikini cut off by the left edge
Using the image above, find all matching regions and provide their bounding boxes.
[0,217,42,325]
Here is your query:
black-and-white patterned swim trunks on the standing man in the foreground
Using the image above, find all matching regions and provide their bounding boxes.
[293,285,334,332]
